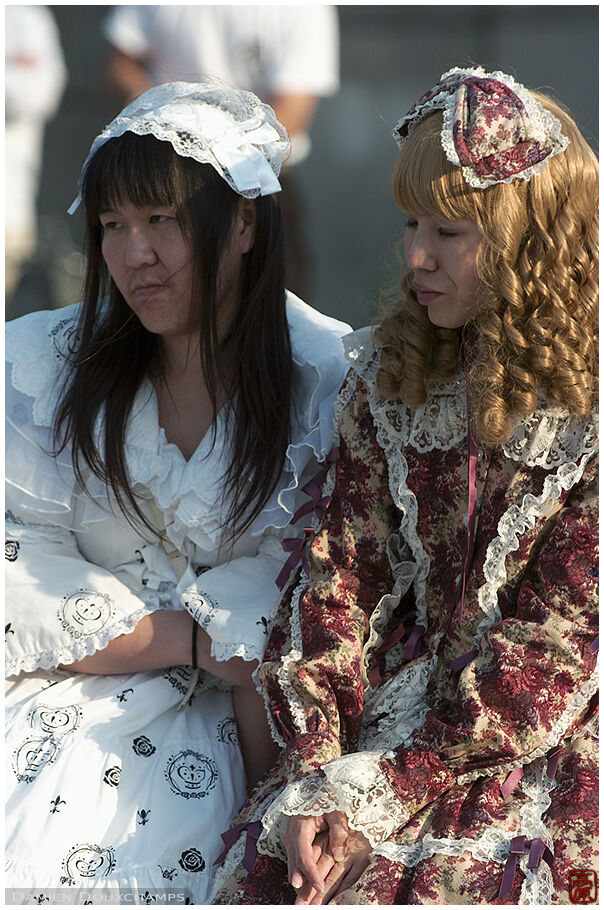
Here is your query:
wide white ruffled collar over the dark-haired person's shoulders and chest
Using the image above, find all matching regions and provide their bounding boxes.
[6,293,350,549]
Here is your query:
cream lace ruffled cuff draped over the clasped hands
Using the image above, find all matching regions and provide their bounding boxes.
[258,752,409,858]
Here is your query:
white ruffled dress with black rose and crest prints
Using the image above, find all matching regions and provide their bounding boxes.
[5,295,348,904]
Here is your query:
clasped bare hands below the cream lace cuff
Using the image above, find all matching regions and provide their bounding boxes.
[283,812,372,904]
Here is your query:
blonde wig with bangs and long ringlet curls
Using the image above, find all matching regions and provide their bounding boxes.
[377,92,598,446]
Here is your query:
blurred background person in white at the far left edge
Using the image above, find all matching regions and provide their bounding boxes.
[4,5,67,315]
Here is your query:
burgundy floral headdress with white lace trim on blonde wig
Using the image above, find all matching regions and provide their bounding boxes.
[393,67,569,189]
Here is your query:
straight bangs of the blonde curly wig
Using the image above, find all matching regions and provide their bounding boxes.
[392,112,480,221]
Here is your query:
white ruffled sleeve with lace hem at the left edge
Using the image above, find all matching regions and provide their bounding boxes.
[5,308,156,675]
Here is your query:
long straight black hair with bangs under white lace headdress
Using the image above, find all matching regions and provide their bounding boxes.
[54,133,292,539]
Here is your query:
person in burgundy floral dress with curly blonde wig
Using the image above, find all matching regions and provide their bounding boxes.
[216,68,598,904]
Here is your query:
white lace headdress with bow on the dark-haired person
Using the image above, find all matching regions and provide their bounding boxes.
[69,82,291,214]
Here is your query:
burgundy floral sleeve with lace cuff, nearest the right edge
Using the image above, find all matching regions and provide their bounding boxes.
[259,442,598,855]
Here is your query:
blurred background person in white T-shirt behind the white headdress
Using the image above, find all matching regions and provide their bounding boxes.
[103,5,339,296]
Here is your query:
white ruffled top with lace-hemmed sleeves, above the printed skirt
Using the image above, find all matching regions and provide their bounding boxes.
[6,295,349,674]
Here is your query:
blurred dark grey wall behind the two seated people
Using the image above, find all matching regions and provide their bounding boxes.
[11,4,598,327]
